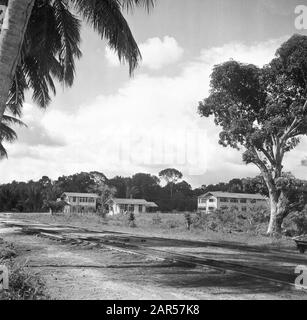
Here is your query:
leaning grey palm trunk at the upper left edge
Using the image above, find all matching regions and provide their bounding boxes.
[0,0,35,123]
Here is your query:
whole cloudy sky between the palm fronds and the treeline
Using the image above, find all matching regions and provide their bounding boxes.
[0,0,307,187]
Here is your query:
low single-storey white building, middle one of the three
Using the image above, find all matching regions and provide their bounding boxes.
[108,198,158,215]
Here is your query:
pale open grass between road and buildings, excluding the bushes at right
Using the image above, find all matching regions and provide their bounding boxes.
[13,213,296,251]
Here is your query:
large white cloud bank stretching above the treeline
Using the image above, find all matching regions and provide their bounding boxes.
[0,39,306,183]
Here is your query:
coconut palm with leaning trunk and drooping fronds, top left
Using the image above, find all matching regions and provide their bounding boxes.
[0,0,154,122]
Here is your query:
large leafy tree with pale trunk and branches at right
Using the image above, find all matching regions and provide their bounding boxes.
[199,35,307,234]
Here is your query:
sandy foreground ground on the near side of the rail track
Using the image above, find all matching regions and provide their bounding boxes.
[0,219,307,300]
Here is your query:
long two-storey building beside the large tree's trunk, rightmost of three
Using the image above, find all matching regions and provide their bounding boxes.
[197,191,267,213]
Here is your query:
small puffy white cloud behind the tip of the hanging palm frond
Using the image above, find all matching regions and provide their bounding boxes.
[105,36,183,70]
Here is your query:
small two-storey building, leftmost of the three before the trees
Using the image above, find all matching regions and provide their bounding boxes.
[61,192,99,213]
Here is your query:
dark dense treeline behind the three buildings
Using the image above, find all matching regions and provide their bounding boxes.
[0,169,306,212]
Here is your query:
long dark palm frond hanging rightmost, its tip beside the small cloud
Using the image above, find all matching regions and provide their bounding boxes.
[71,0,141,74]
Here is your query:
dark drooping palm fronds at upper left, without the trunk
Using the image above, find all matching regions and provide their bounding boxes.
[0,0,154,156]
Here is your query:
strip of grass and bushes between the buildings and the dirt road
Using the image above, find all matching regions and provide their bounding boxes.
[12,213,295,250]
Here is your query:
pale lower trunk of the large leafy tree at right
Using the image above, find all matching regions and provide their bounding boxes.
[267,192,288,236]
